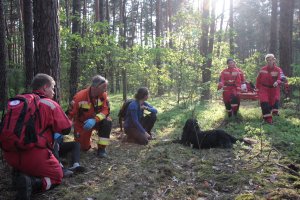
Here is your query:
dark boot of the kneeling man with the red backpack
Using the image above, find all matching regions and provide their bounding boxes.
[16,174,32,200]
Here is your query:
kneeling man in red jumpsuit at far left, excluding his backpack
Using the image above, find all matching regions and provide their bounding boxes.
[4,74,72,200]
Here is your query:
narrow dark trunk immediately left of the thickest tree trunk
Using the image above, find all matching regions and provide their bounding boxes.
[23,0,34,90]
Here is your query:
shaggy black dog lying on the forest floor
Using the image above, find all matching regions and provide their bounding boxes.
[180,119,243,149]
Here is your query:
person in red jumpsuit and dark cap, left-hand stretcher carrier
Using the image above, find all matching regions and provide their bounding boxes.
[218,58,241,117]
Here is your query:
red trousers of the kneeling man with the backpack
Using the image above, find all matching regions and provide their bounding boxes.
[4,148,63,191]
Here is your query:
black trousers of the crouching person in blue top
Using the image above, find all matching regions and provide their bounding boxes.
[125,113,157,145]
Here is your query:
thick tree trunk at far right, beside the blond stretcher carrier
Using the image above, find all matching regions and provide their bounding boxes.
[279,0,295,76]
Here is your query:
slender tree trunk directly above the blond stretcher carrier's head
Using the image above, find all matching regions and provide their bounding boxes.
[269,0,278,56]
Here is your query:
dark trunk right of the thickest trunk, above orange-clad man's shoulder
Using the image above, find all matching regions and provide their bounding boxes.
[69,0,81,101]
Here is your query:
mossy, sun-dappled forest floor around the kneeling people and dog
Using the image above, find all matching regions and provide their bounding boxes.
[0,96,300,200]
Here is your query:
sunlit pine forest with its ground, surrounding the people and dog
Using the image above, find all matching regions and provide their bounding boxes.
[0,0,300,200]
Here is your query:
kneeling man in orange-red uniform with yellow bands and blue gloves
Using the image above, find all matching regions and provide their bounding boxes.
[68,75,112,158]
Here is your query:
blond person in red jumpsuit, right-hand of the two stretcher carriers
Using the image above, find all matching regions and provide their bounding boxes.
[256,54,282,124]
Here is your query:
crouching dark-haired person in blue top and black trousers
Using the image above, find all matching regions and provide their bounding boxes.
[124,87,157,145]
